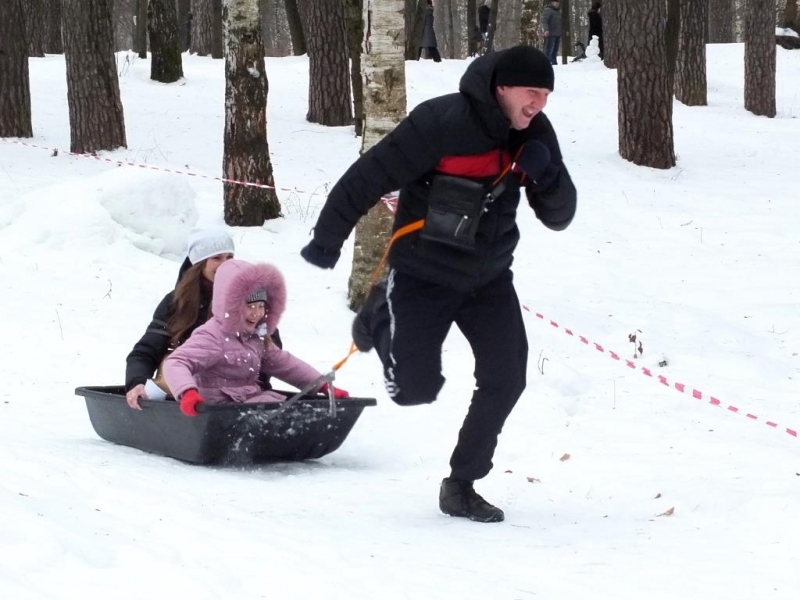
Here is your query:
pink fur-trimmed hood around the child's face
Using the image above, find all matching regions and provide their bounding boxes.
[211,259,286,334]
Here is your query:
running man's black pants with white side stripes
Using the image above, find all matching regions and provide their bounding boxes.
[373,270,528,481]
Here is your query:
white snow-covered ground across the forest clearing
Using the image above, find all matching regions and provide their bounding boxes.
[0,45,800,600]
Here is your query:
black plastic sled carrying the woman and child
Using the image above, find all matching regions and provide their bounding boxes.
[75,386,376,464]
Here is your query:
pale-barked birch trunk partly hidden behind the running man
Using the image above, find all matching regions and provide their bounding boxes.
[348,0,406,310]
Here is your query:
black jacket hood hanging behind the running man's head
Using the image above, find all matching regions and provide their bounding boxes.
[458,50,511,143]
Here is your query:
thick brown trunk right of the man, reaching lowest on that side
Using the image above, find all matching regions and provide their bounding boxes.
[620,0,675,169]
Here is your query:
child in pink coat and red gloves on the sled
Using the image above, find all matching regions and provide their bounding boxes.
[164,260,348,416]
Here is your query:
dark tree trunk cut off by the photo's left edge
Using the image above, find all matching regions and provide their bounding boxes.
[0,0,33,138]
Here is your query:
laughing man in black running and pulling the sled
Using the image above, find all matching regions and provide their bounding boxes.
[301,46,577,522]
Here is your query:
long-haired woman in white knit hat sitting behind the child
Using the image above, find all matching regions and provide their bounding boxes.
[125,229,282,409]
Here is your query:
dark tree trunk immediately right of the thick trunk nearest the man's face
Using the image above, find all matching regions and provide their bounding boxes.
[675,0,708,106]
